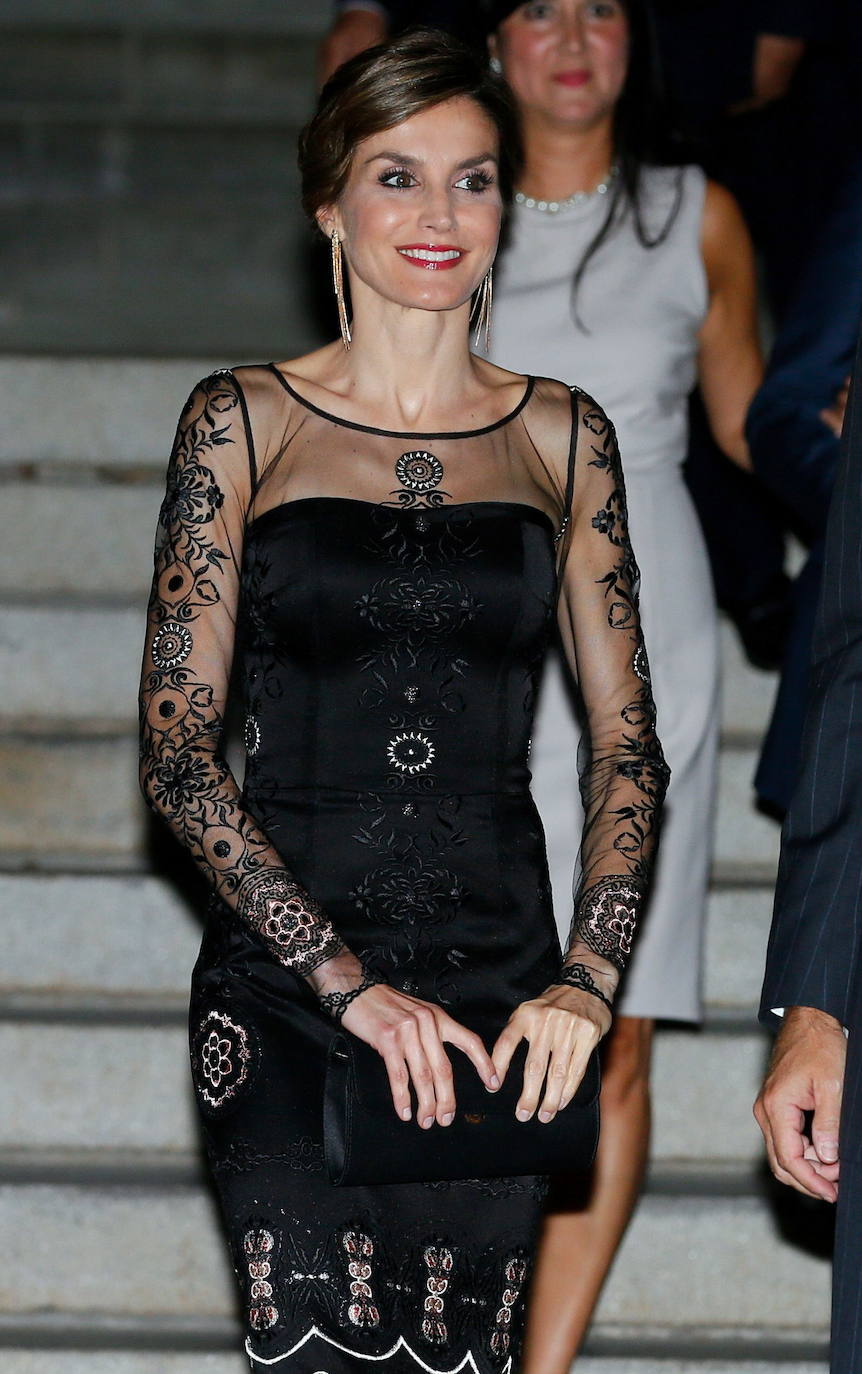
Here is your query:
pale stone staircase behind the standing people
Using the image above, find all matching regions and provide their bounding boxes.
[0,0,829,1374]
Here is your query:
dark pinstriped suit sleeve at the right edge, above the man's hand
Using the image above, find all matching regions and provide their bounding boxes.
[760,327,862,1025]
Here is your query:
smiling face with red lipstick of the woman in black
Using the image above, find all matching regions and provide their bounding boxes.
[319,96,503,311]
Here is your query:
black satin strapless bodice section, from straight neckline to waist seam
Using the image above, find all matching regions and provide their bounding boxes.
[239,496,555,796]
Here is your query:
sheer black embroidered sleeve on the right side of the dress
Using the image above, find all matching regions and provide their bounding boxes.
[560,393,670,1002]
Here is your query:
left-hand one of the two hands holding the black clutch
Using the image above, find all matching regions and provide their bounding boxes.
[341,982,500,1129]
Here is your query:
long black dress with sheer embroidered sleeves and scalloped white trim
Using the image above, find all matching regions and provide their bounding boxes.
[142,365,665,1374]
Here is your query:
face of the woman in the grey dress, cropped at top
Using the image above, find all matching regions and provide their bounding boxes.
[492,0,630,129]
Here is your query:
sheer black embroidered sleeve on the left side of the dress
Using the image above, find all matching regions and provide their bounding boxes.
[140,372,382,1015]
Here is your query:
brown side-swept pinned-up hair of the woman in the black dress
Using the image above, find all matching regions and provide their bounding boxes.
[298,29,521,224]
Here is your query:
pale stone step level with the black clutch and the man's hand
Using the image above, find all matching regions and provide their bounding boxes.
[0,1004,769,1172]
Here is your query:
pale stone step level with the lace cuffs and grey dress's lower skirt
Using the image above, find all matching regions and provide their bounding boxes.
[0,872,773,1015]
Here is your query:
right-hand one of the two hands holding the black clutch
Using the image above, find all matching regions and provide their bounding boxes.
[491,984,612,1121]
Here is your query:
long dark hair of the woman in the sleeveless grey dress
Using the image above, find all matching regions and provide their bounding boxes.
[489,0,683,330]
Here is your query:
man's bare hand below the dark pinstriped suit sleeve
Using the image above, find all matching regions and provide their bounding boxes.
[755,1007,847,1202]
